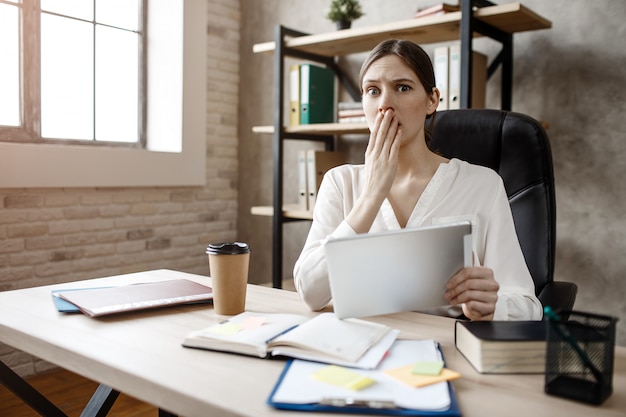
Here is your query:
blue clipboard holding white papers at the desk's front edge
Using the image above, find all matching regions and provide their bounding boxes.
[267,340,461,417]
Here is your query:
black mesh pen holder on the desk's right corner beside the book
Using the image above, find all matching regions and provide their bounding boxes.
[545,311,617,404]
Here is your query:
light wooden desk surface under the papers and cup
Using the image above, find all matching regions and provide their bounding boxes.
[0,270,626,417]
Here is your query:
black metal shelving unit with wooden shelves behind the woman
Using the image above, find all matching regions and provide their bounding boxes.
[251,0,552,288]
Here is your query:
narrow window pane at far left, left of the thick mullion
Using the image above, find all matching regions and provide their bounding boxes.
[0,4,20,126]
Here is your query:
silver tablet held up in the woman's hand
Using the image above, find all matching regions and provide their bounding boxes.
[324,221,472,318]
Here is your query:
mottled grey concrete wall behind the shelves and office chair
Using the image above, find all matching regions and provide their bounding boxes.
[239,0,626,345]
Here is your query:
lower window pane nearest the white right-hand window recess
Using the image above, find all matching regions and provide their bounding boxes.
[96,26,139,142]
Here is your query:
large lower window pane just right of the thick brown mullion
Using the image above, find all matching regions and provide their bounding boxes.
[41,14,93,139]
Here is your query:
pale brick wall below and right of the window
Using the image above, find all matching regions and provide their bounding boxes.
[0,0,240,376]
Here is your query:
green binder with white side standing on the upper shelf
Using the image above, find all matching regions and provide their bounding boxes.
[300,64,335,125]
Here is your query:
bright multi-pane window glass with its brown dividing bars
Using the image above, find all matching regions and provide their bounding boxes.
[0,0,145,144]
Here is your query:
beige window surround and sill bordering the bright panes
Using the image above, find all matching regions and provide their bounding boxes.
[0,0,208,188]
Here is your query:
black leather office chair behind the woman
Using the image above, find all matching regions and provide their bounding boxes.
[430,109,578,311]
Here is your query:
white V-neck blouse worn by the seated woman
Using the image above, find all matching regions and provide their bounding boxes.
[294,159,542,320]
